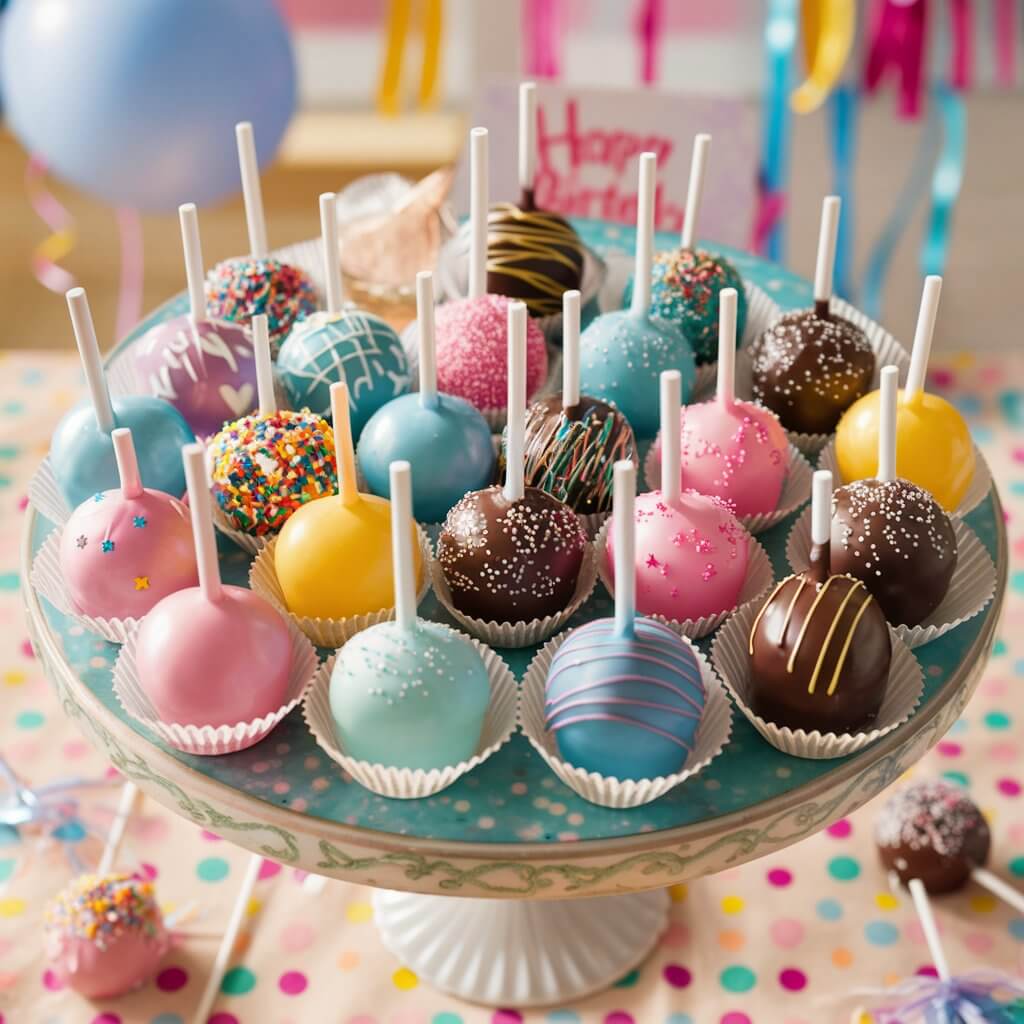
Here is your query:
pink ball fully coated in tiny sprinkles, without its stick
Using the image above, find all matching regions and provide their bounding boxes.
[434,295,548,412]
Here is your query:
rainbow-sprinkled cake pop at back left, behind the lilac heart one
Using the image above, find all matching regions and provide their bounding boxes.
[206,121,316,350]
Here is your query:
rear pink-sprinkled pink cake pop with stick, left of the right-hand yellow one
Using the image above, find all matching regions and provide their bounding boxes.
[653,288,790,516]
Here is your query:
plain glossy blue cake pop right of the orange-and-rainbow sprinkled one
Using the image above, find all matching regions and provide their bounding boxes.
[357,270,495,522]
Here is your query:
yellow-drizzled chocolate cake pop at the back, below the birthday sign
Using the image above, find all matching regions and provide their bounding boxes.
[487,82,584,316]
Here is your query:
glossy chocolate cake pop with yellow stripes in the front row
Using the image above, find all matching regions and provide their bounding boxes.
[748,470,892,733]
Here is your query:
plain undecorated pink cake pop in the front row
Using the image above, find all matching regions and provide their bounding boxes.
[135,444,292,727]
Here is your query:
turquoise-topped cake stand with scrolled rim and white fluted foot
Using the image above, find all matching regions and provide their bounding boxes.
[23,221,1007,1006]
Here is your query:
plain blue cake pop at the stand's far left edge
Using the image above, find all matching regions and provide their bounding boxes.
[50,288,196,508]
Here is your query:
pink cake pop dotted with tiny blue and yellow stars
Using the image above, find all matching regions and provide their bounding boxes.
[60,427,199,618]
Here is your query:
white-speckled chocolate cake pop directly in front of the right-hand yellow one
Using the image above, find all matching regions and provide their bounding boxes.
[829,367,956,626]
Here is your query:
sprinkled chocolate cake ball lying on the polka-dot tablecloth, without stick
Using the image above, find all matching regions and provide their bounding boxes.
[874,779,991,893]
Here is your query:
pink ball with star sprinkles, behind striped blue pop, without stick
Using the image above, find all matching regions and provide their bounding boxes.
[604,490,750,622]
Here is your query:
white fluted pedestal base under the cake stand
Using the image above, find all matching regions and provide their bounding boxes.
[374,890,669,1007]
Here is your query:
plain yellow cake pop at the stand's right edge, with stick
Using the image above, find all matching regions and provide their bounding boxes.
[836,276,974,512]
